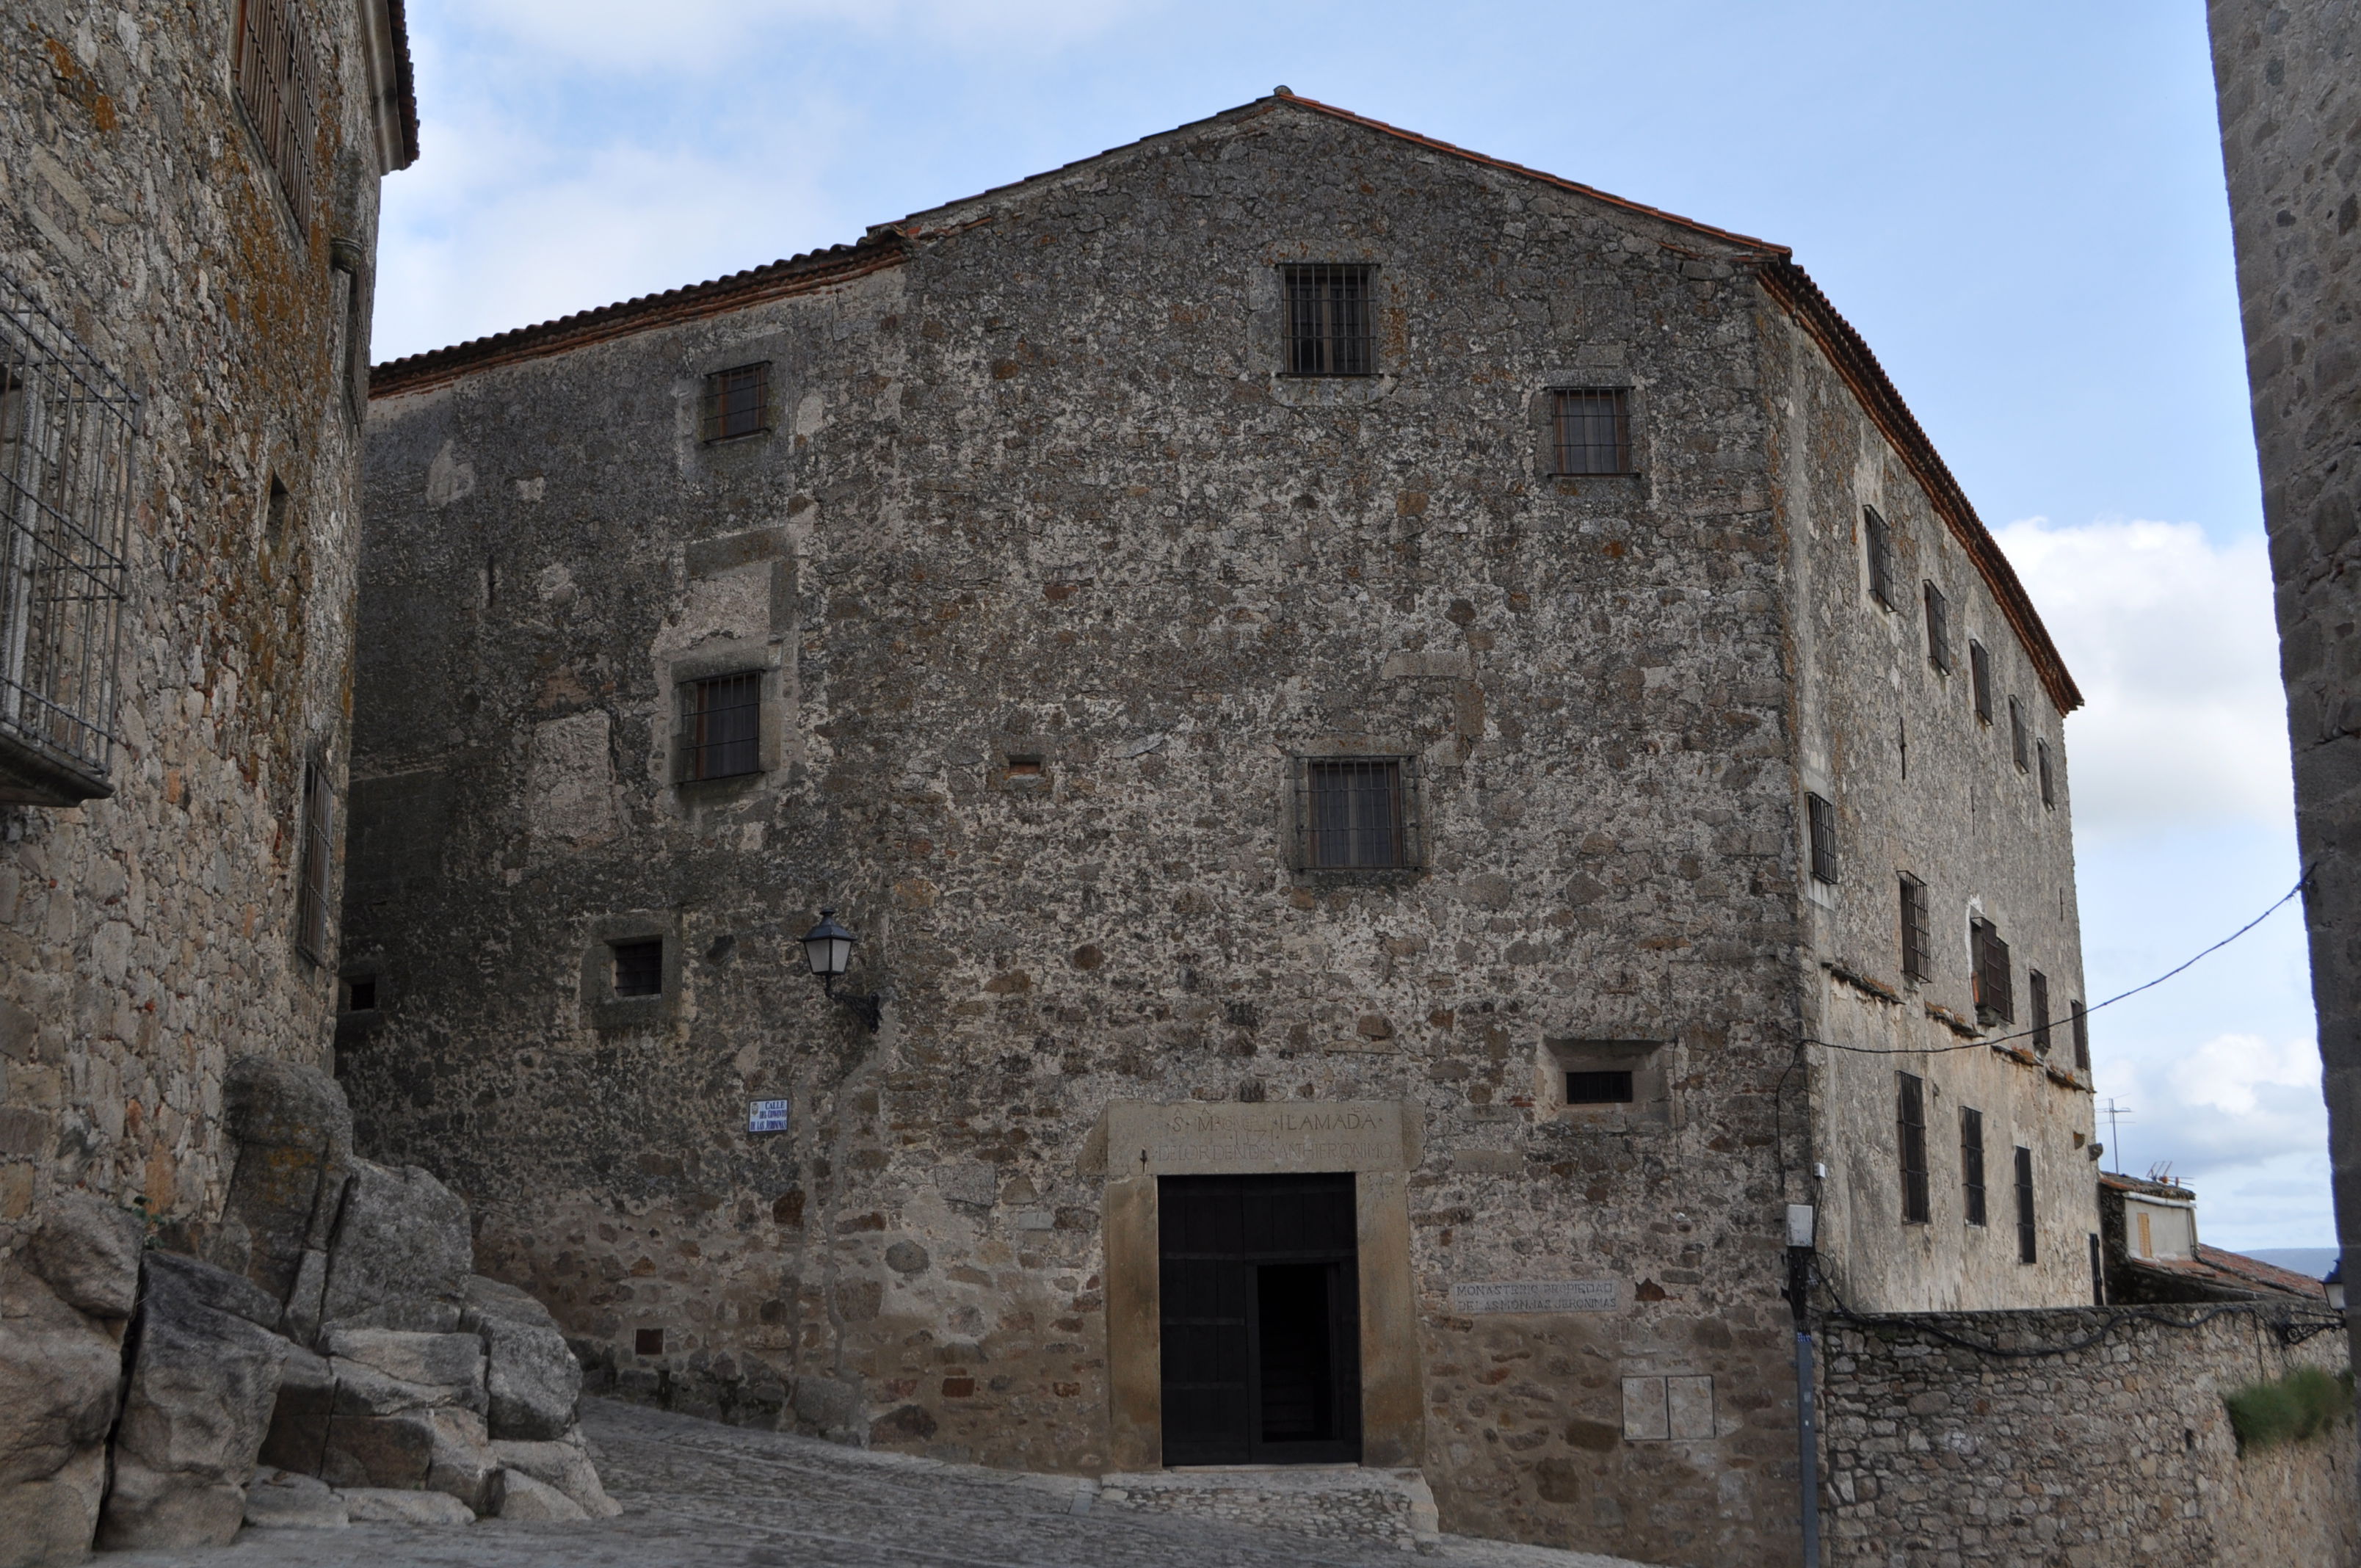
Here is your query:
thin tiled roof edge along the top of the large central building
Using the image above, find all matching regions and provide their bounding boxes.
[369,87,2083,713]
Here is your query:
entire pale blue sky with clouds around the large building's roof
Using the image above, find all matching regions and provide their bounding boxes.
[375,0,2335,1247]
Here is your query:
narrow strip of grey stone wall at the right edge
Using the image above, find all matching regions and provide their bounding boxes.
[2205,0,2361,1360]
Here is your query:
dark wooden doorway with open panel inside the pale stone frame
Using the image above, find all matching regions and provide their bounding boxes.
[1157,1174,1360,1464]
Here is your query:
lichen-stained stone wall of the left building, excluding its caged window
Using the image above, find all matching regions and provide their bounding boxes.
[0,0,396,1223]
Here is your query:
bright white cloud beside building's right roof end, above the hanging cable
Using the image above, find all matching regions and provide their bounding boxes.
[1998,517,2293,836]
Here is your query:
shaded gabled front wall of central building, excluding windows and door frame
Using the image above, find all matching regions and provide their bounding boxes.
[338,104,2078,1564]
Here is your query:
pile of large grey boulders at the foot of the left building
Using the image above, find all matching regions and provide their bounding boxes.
[0,1060,621,1568]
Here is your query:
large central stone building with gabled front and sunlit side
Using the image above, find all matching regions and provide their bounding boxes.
[338,90,2095,1564]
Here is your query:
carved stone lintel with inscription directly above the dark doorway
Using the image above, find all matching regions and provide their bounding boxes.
[1107,1100,1417,1176]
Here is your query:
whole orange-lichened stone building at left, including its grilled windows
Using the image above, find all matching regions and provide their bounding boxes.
[0,0,418,1256]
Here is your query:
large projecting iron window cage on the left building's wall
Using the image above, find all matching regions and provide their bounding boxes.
[0,272,139,805]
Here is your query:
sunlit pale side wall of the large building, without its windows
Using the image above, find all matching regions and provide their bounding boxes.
[1763,316,2097,1310]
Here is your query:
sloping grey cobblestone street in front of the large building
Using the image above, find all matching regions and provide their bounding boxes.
[97,1401,1633,1568]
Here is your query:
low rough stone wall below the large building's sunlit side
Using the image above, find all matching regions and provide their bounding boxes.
[1821,1304,2361,1568]
